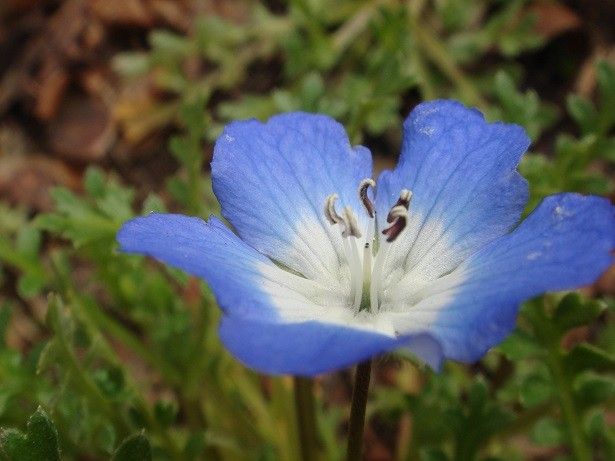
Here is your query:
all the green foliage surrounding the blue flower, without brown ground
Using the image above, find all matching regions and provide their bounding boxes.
[0,0,615,461]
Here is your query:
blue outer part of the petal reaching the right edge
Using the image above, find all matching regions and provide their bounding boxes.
[428,194,615,362]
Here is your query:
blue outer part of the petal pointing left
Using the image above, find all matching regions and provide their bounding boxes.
[117,213,278,319]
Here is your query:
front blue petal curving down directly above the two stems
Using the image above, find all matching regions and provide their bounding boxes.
[220,316,442,376]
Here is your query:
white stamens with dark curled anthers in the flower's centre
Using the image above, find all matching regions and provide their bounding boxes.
[324,178,412,312]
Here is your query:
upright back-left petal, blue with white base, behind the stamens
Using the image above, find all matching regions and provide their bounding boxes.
[212,113,371,281]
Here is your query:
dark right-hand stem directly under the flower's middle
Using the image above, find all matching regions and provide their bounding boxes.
[346,360,372,461]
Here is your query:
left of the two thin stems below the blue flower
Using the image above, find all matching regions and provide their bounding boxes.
[294,376,318,461]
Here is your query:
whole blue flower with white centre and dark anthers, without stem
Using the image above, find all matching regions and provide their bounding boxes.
[117,100,615,376]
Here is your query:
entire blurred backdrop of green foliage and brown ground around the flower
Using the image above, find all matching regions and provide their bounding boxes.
[0,0,615,460]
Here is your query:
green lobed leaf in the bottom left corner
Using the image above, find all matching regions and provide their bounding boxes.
[0,407,60,461]
